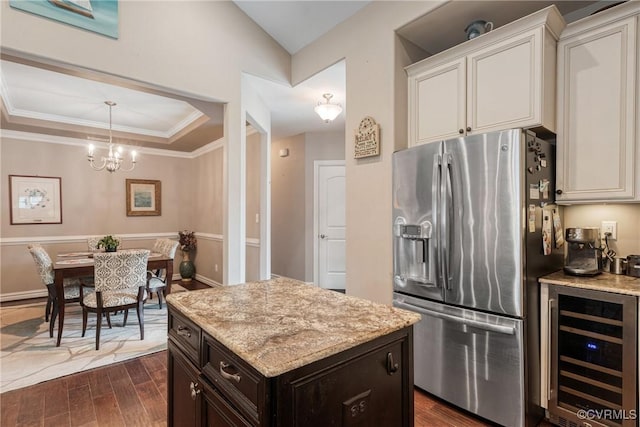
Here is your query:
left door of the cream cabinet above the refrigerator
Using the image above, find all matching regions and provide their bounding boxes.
[409,58,466,146]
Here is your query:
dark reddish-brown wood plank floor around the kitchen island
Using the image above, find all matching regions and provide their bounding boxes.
[0,351,550,427]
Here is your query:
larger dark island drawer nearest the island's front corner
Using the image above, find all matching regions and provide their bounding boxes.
[202,334,265,424]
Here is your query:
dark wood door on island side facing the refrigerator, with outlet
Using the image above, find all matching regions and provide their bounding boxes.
[278,340,413,427]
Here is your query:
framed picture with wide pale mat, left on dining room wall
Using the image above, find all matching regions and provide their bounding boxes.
[9,175,62,224]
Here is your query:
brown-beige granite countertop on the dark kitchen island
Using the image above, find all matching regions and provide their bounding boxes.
[167,278,420,377]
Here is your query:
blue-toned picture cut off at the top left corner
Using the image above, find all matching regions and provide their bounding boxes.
[9,0,118,39]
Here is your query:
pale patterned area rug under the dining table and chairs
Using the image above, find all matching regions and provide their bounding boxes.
[0,285,185,393]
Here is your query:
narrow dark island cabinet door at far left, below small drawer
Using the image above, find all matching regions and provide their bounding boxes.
[167,341,202,427]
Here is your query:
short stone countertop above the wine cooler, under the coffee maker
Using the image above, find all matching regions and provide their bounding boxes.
[540,270,640,296]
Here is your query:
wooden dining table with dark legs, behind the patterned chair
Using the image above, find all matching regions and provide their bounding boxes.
[53,252,173,347]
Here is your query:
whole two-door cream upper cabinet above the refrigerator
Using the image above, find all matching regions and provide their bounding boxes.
[407,6,564,146]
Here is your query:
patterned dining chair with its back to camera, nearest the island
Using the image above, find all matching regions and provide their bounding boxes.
[82,249,149,350]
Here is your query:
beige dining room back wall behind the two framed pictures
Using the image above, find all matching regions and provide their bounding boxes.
[0,137,199,299]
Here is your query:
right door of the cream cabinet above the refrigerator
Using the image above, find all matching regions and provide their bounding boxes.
[467,27,544,133]
